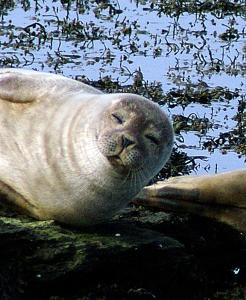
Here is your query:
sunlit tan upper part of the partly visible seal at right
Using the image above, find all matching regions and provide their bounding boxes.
[138,169,246,209]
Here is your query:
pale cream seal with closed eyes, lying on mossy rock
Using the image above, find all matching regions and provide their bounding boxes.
[0,69,173,226]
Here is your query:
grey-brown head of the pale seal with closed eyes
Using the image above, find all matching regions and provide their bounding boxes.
[98,94,173,184]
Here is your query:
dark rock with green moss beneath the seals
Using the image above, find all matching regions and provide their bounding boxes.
[0,207,245,300]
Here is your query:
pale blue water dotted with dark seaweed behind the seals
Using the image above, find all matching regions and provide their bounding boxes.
[0,0,246,173]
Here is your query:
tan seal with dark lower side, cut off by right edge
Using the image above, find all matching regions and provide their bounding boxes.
[133,169,246,232]
